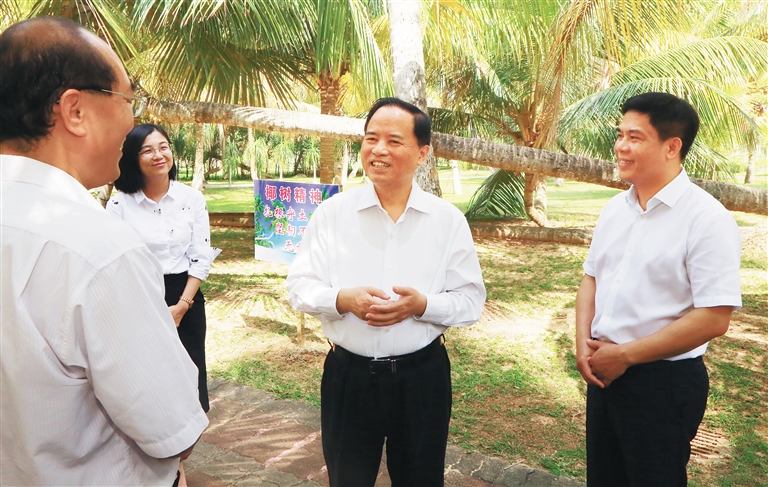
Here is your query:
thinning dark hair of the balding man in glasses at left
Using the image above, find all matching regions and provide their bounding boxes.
[0,17,117,145]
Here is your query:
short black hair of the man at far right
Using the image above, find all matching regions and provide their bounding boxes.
[621,92,699,161]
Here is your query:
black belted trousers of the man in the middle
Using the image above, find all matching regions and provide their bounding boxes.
[321,339,452,487]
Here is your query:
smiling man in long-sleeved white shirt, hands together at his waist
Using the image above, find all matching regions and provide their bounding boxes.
[286,98,485,487]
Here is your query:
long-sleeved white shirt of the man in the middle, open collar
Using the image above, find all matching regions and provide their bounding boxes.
[286,183,485,358]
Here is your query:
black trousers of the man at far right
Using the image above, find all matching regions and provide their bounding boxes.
[587,357,709,487]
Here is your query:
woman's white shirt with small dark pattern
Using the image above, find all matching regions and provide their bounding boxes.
[107,181,213,281]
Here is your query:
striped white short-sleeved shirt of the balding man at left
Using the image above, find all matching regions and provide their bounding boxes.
[0,155,208,486]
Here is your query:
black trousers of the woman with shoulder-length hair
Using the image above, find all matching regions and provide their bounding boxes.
[164,272,211,413]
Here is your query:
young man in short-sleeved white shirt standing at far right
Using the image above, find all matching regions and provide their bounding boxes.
[576,93,741,487]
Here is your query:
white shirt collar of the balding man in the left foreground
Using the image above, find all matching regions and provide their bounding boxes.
[0,154,103,210]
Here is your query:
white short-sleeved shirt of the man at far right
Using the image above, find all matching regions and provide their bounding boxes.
[584,171,741,360]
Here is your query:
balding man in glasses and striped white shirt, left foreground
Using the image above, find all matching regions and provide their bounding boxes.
[0,18,208,487]
